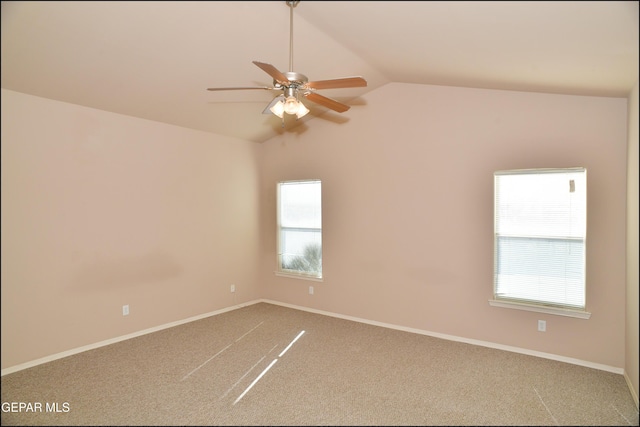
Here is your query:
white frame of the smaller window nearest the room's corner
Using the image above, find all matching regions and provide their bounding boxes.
[274,179,323,282]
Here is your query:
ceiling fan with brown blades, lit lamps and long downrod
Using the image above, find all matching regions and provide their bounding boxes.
[207,0,367,126]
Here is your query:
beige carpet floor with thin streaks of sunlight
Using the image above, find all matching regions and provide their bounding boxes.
[2,303,638,426]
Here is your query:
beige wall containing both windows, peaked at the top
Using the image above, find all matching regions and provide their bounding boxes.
[261,83,627,369]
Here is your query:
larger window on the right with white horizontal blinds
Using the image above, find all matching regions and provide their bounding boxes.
[492,168,588,318]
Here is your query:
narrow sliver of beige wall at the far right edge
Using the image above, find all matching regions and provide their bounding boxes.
[625,82,640,406]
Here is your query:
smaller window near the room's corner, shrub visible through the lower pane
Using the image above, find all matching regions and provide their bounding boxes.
[276,180,322,279]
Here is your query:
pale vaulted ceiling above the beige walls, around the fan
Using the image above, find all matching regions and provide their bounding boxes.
[1,1,639,142]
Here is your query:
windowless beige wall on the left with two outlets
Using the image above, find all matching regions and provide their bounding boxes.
[1,89,260,369]
